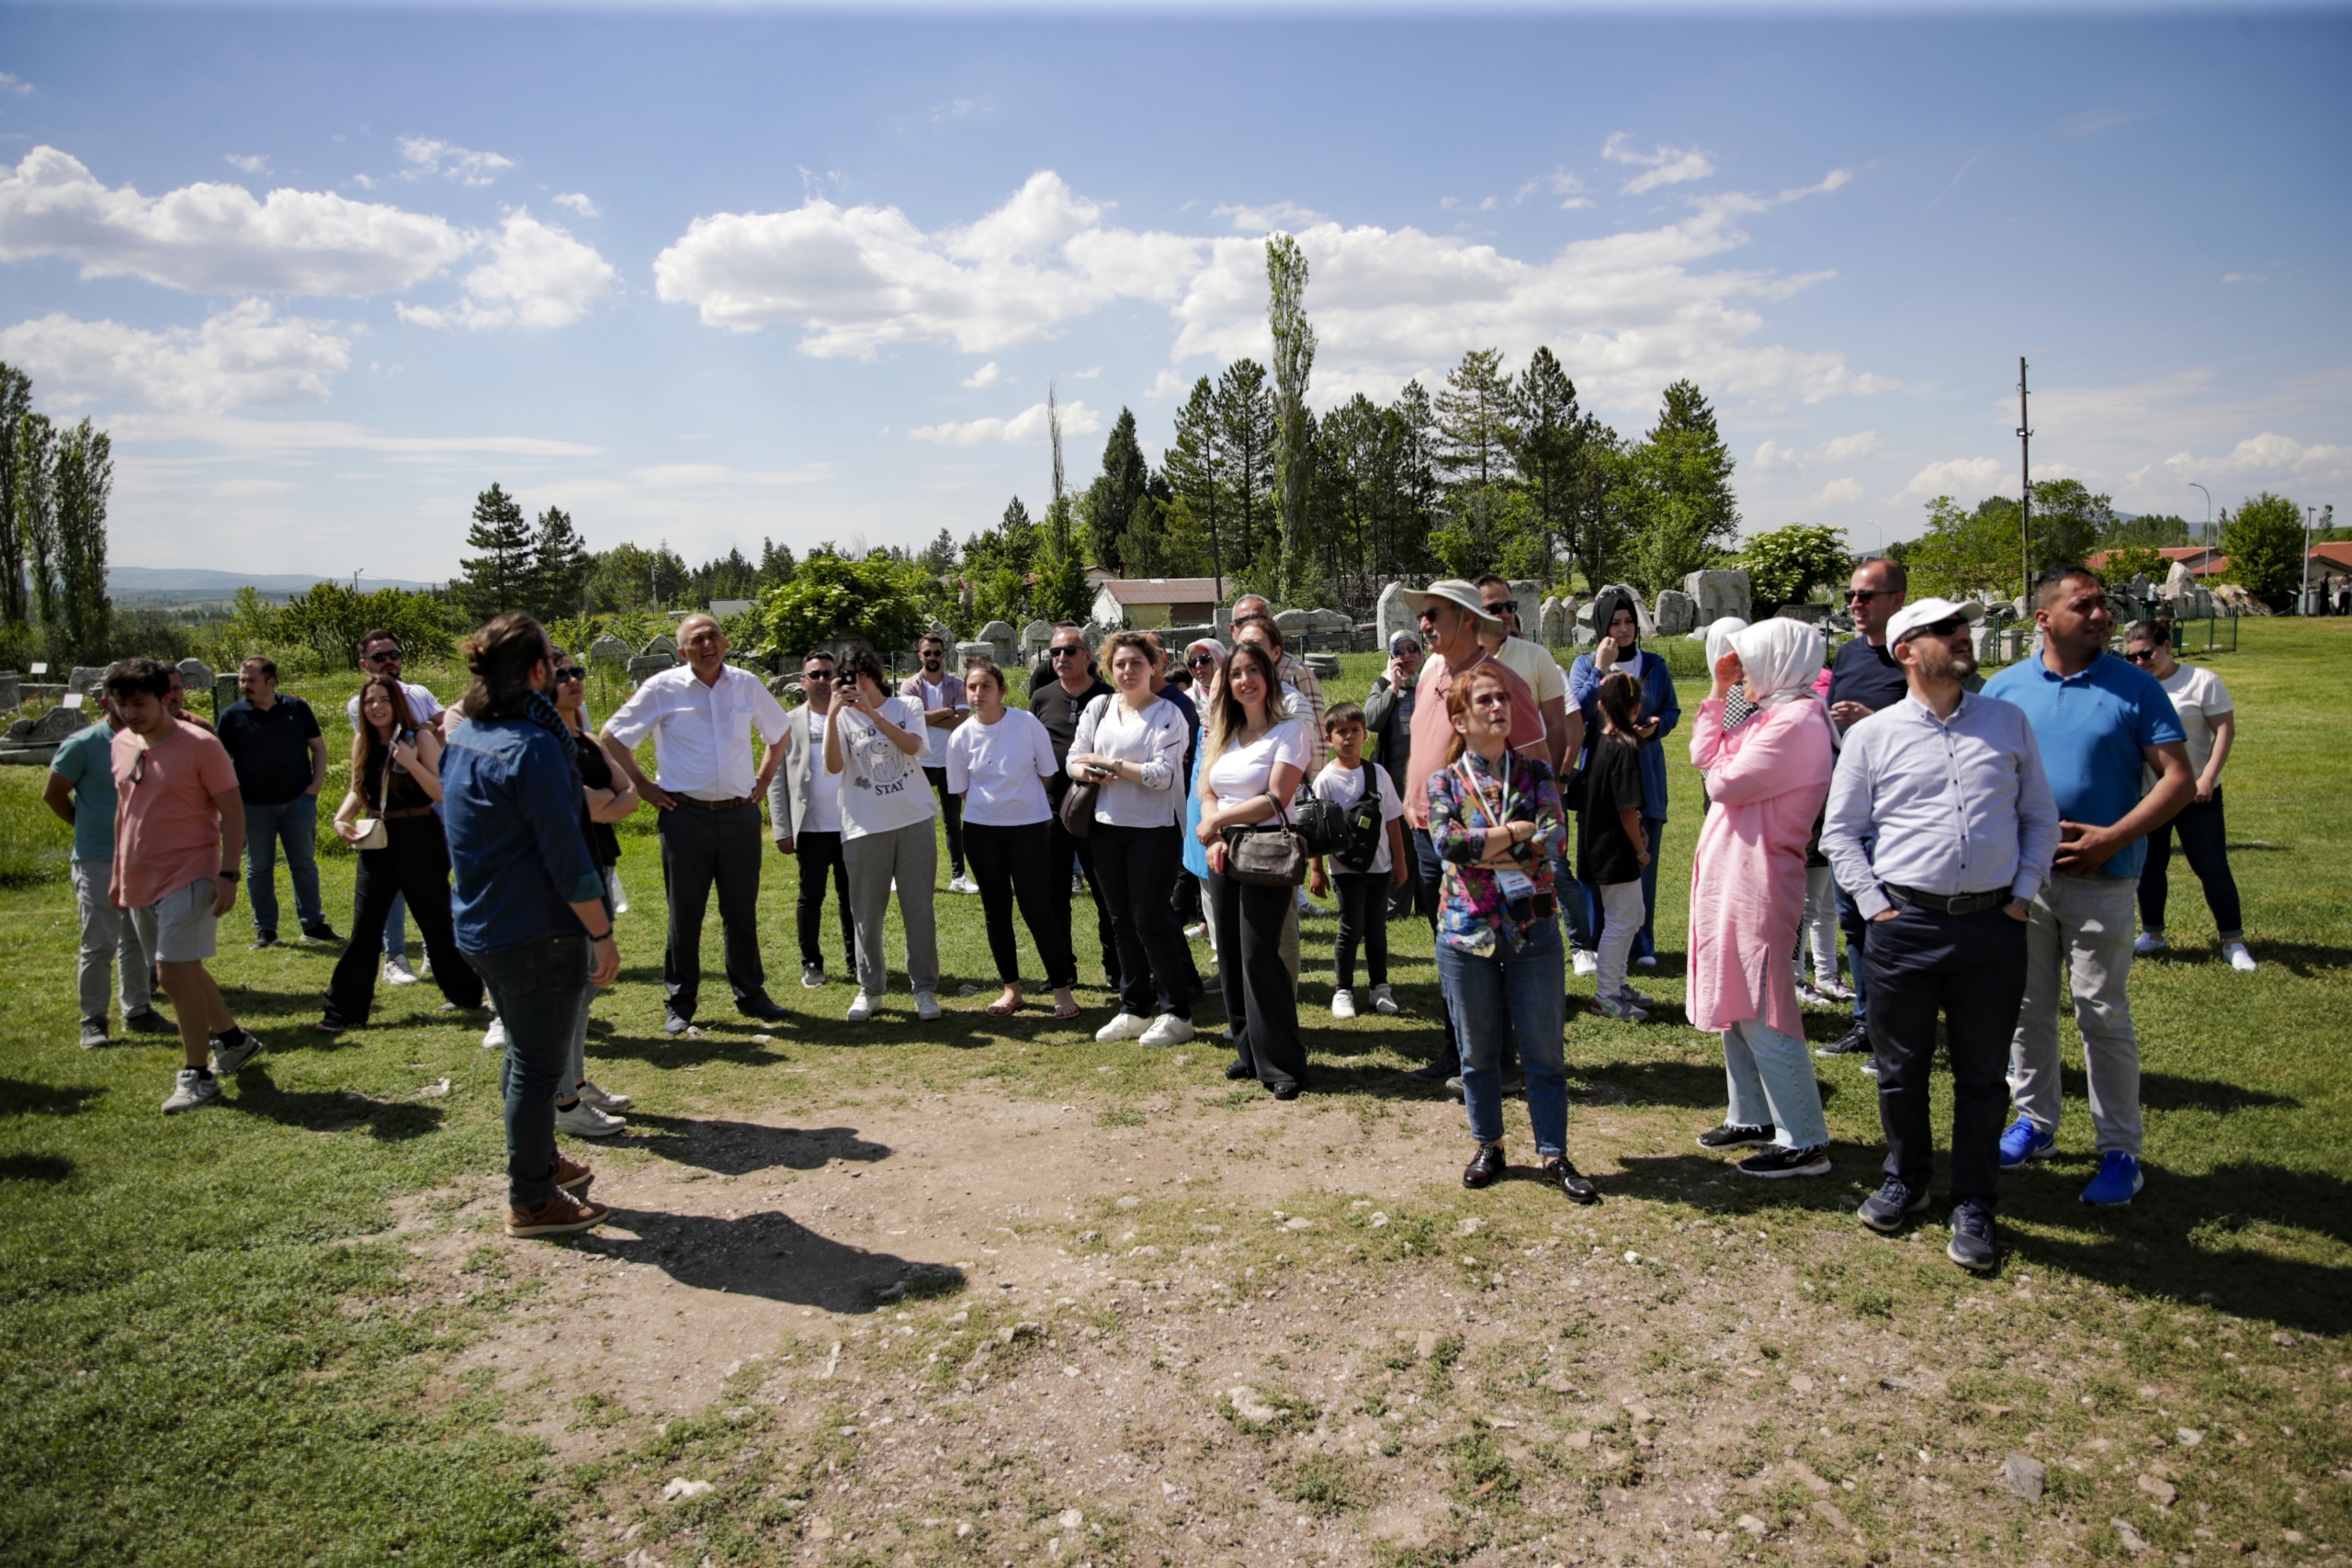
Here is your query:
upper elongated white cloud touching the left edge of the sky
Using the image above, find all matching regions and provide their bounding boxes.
[0,146,475,296]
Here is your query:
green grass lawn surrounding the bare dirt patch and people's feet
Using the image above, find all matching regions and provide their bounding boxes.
[0,621,2352,1565]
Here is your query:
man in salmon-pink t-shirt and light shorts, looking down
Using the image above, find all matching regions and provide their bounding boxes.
[106,659,261,1117]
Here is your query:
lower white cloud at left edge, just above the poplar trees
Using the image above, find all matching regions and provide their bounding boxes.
[0,299,350,413]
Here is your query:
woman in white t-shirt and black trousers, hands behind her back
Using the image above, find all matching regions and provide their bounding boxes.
[945,659,1077,1018]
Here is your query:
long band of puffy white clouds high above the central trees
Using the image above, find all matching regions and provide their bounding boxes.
[654,169,1894,412]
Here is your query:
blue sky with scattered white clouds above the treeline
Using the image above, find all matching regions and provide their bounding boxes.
[0,7,2352,579]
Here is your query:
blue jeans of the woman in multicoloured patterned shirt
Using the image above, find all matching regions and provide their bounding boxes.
[1437,917,1569,1159]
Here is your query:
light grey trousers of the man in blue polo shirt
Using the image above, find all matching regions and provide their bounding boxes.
[2008,872,2141,1159]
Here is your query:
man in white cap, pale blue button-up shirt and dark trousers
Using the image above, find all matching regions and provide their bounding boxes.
[1820,600,2058,1272]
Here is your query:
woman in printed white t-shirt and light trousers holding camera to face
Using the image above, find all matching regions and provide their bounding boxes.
[826,647,938,1022]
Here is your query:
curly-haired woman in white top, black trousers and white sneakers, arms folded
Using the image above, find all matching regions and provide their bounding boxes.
[1070,632,1194,1046]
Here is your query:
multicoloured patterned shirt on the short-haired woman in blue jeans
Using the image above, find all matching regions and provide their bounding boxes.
[1430,752,1569,954]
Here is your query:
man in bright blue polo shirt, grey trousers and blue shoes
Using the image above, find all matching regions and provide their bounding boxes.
[1985,567,2197,1203]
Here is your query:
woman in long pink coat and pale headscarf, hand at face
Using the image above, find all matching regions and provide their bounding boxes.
[1689,621,1835,1176]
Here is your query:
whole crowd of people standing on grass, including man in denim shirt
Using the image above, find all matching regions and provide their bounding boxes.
[47,559,2253,1269]
